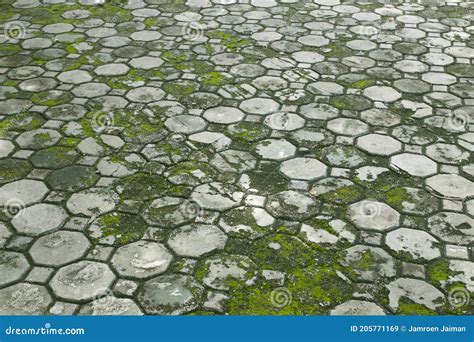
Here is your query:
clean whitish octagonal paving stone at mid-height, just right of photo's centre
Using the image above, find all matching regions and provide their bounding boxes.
[280,158,328,180]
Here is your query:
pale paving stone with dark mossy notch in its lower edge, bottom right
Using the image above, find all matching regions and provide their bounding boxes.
[386,278,444,310]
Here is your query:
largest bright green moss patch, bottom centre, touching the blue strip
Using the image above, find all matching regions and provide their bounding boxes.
[222,234,353,315]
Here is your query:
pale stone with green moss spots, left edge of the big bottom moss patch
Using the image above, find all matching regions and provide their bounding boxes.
[203,255,256,290]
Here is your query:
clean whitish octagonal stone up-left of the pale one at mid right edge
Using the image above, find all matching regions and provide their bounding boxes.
[390,153,438,177]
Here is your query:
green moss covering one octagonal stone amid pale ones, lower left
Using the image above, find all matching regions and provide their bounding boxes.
[94,213,148,246]
